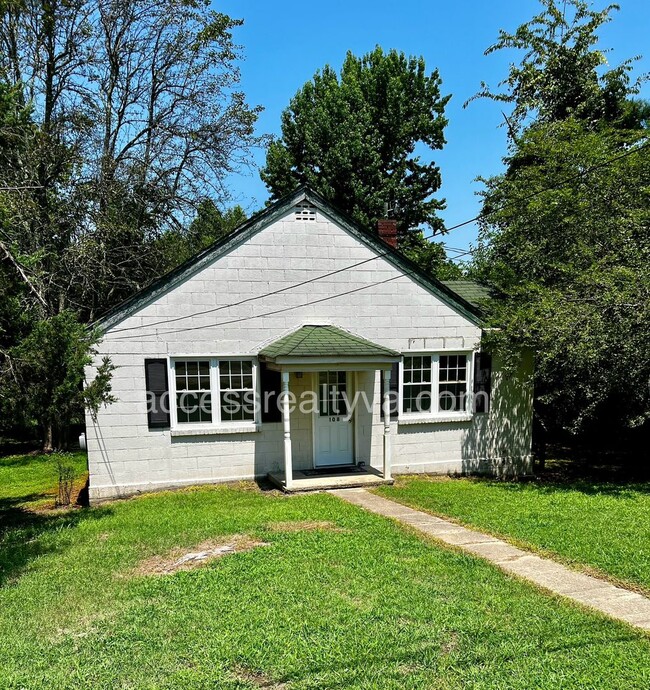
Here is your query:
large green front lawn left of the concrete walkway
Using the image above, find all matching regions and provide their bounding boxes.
[0,454,650,690]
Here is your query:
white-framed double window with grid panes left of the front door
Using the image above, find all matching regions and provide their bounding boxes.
[172,358,257,426]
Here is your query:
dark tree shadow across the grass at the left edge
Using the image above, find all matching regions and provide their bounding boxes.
[0,494,113,587]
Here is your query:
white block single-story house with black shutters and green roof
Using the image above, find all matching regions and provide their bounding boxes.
[87,189,532,501]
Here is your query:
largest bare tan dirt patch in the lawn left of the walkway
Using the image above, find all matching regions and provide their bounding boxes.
[134,534,269,575]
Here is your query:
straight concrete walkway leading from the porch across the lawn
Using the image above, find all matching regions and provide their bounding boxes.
[330,489,650,630]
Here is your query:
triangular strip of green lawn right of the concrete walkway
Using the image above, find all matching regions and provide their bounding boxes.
[378,477,650,591]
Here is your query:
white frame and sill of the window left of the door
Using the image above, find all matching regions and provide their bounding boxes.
[167,355,261,436]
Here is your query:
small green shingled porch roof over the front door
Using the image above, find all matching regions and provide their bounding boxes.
[259,326,400,359]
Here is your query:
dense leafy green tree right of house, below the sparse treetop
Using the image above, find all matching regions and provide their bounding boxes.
[476,120,650,432]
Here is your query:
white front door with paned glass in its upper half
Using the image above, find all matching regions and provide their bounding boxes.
[314,371,354,467]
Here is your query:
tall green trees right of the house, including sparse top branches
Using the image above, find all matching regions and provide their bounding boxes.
[473,0,650,440]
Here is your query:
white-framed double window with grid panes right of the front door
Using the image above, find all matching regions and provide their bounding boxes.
[401,353,468,417]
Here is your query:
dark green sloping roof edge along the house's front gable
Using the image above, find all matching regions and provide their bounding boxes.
[93,187,481,332]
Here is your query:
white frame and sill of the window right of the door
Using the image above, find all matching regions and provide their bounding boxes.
[397,350,474,424]
